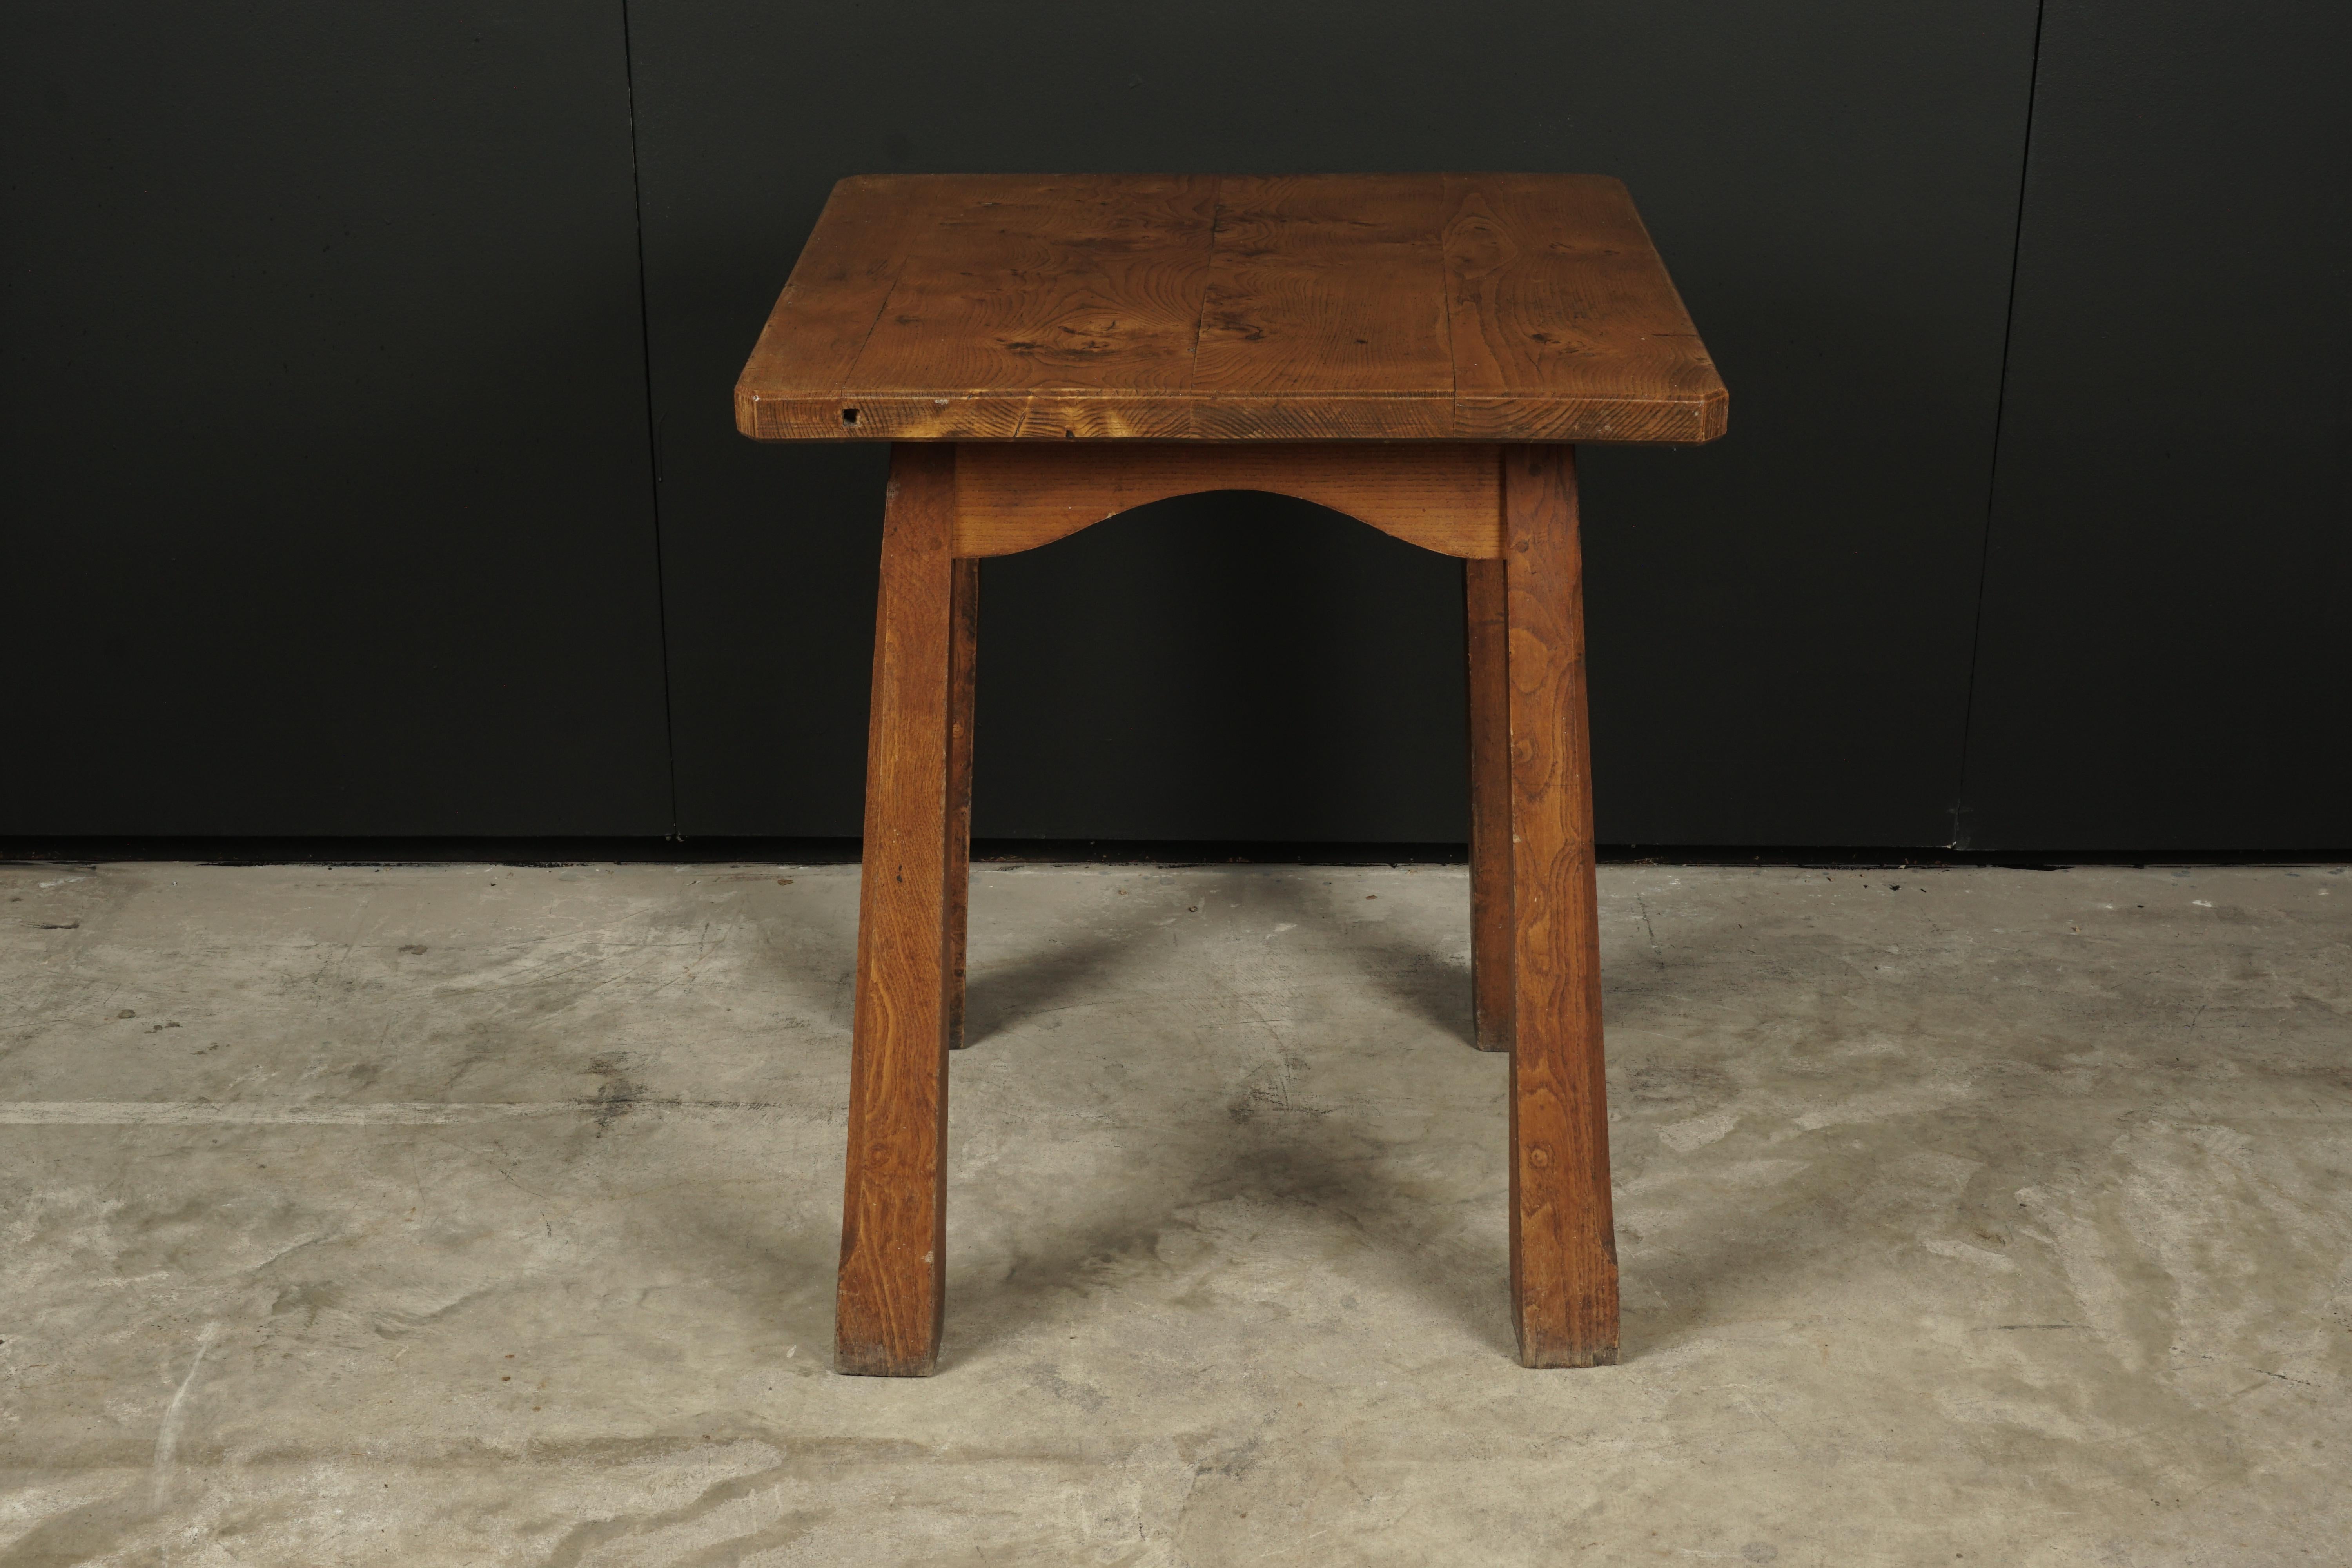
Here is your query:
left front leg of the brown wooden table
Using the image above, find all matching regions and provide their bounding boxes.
[833,444,957,1377]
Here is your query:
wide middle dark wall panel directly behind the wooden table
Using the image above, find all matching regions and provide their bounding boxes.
[630,0,2034,844]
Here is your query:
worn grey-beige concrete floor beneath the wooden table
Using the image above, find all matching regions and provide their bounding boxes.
[0,865,2352,1568]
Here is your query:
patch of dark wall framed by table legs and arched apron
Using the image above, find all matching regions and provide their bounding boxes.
[974,494,1470,844]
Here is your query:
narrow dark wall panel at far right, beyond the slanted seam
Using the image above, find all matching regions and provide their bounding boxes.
[1964,0,2352,849]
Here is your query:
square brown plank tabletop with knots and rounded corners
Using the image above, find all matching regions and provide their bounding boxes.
[736,174,1724,442]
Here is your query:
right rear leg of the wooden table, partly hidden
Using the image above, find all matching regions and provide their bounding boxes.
[1463,559,1512,1051]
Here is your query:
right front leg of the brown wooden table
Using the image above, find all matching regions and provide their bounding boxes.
[1503,446,1618,1366]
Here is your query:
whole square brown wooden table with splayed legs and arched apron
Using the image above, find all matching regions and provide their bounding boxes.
[736,174,1724,1375]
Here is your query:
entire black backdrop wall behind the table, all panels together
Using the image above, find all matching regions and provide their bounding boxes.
[0,0,2352,851]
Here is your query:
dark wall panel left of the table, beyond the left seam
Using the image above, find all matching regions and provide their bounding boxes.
[0,0,670,835]
